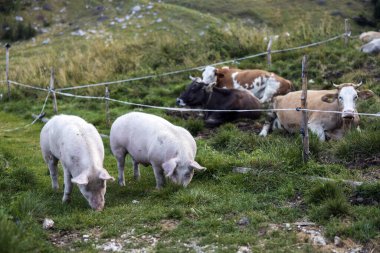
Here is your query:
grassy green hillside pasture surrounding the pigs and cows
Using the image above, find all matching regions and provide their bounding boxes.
[0,1,380,252]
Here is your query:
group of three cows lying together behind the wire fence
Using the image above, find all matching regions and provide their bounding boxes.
[177,66,374,141]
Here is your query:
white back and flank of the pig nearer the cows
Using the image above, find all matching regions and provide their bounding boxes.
[110,112,196,163]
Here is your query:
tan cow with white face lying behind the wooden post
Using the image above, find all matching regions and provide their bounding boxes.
[260,83,374,141]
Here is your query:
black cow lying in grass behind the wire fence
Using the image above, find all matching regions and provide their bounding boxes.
[177,78,261,127]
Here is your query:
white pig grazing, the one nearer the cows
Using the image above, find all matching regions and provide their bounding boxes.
[110,112,206,189]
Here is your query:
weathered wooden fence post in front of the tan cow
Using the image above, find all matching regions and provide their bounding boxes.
[301,55,309,163]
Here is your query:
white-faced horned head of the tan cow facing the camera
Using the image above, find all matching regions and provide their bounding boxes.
[322,83,374,119]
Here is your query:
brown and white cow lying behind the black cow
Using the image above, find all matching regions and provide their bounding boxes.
[202,66,293,103]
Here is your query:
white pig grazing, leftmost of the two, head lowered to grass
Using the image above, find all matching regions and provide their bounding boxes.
[40,115,115,211]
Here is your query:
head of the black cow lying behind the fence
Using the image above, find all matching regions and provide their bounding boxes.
[176,76,212,106]
